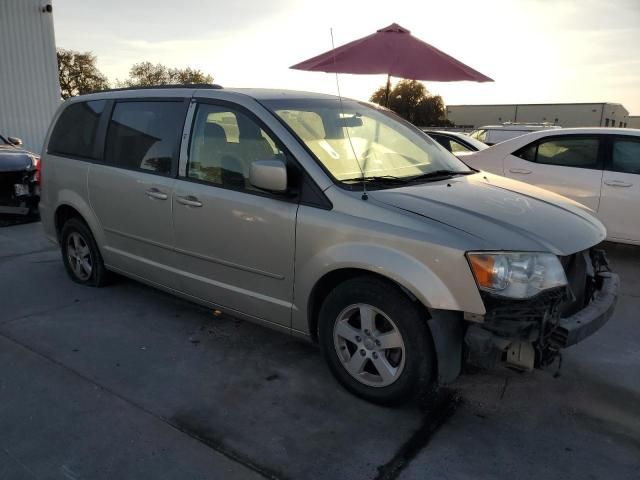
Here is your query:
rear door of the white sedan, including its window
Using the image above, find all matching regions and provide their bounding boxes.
[504,135,604,211]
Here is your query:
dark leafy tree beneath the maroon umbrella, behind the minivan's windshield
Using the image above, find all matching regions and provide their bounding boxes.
[370,80,452,127]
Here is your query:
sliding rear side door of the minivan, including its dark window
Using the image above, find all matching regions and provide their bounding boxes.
[89,98,188,288]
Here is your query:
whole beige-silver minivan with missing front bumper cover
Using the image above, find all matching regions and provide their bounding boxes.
[41,87,618,404]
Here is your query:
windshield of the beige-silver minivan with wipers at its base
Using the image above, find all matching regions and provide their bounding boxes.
[262,98,470,183]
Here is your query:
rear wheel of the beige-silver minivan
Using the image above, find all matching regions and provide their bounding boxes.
[60,218,109,287]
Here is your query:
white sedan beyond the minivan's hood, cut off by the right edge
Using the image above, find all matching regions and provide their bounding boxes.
[465,128,640,245]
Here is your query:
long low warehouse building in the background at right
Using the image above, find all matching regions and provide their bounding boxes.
[447,102,631,128]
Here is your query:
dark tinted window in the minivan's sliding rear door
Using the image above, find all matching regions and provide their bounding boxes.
[105,102,184,175]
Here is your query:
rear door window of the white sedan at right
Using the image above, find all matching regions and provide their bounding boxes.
[536,137,599,168]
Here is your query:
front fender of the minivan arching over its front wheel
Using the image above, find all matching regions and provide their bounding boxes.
[291,242,484,334]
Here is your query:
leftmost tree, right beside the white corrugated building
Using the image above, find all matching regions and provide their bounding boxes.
[57,48,109,100]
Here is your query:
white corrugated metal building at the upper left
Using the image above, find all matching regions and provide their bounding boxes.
[0,0,60,153]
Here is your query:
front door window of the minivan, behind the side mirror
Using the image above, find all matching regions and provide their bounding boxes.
[187,105,284,190]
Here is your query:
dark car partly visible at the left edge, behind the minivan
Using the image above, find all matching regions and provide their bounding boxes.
[0,135,40,215]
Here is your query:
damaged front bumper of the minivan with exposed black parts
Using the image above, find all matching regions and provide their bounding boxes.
[464,251,620,370]
